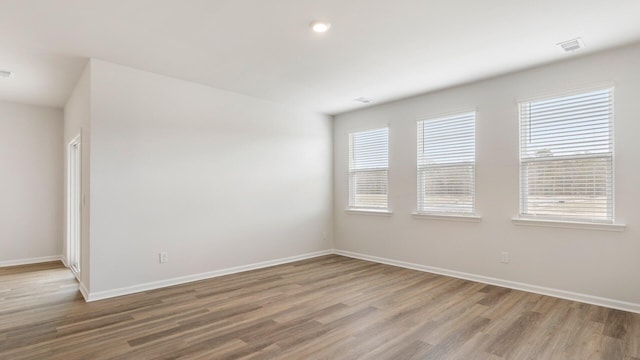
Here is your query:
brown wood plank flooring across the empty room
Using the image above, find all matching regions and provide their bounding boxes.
[0,255,640,360]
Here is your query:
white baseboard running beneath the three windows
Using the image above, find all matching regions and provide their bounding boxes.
[333,249,640,313]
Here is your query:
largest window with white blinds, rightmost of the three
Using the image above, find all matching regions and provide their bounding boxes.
[520,89,613,222]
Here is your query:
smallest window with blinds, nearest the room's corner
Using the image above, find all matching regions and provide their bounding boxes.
[349,128,389,210]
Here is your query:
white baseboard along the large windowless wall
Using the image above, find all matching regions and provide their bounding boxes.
[86,250,333,302]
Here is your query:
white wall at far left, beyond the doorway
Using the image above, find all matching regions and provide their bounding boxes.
[0,101,63,265]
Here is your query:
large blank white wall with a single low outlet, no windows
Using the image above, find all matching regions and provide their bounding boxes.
[90,60,333,293]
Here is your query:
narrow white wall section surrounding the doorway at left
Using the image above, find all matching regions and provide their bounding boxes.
[63,63,91,291]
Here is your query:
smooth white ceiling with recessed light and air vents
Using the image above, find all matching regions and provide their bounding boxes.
[0,0,640,114]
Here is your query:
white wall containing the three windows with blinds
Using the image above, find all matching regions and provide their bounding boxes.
[334,45,640,310]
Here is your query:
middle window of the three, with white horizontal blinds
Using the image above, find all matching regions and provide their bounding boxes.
[418,112,476,215]
